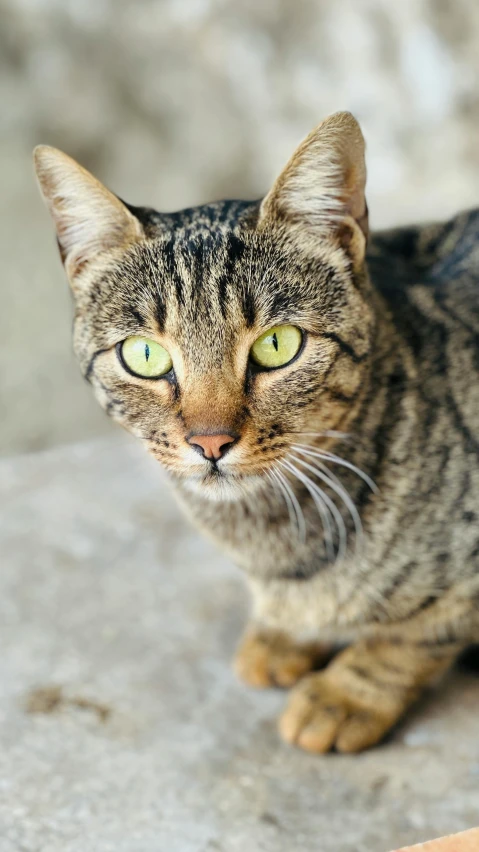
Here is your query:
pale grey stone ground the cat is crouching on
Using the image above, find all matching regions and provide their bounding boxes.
[0,438,479,852]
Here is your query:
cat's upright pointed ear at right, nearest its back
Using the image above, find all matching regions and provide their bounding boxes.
[260,112,368,268]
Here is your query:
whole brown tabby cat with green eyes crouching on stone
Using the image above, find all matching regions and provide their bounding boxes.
[35,112,479,752]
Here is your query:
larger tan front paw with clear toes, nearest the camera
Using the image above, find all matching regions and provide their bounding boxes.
[279,669,403,753]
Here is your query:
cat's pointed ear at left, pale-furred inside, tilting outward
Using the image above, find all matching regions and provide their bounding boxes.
[34,145,143,283]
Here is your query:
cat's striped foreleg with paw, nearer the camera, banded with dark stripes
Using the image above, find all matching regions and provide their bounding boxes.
[279,637,466,752]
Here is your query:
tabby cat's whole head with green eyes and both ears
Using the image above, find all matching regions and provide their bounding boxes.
[35,113,374,499]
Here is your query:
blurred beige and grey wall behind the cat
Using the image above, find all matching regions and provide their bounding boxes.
[0,0,479,453]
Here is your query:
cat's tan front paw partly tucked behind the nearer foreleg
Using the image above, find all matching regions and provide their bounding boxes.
[234,624,331,687]
